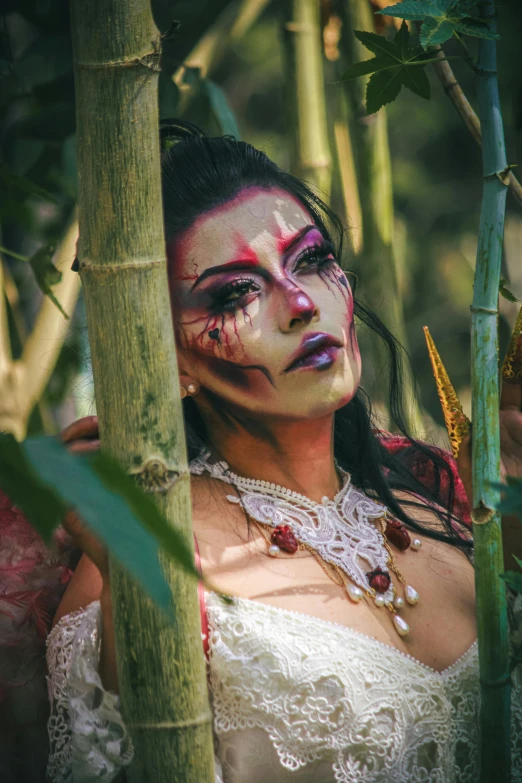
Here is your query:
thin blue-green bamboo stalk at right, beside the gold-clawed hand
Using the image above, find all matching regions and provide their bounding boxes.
[471,0,511,783]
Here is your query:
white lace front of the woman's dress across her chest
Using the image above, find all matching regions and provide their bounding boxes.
[207,594,479,783]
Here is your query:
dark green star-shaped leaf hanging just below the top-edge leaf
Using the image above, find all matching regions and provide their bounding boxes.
[342,22,433,114]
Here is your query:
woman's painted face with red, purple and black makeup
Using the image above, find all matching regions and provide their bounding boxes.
[169,187,361,419]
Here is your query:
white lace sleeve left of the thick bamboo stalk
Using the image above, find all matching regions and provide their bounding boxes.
[47,601,134,783]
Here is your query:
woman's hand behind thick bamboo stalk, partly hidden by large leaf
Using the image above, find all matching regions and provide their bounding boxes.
[60,416,109,588]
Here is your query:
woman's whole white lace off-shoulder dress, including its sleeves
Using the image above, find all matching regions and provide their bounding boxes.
[48,593,522,783]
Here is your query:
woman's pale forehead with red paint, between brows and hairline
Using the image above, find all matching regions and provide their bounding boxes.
[176,188,313,268]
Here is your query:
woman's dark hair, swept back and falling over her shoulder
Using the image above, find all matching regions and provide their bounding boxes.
[161,120,471,548]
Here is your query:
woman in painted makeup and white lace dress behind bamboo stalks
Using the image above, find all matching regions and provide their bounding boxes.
[44,123,522,783]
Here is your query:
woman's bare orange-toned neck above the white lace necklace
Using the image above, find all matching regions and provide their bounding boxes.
[201,414,341,502]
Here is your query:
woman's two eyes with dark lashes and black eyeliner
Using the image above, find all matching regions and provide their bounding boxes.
[208,240,336,313]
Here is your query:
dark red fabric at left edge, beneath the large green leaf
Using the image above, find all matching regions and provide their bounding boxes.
[0,491,73,783]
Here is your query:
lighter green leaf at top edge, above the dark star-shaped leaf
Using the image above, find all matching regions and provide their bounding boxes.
[377,0,500,49]
